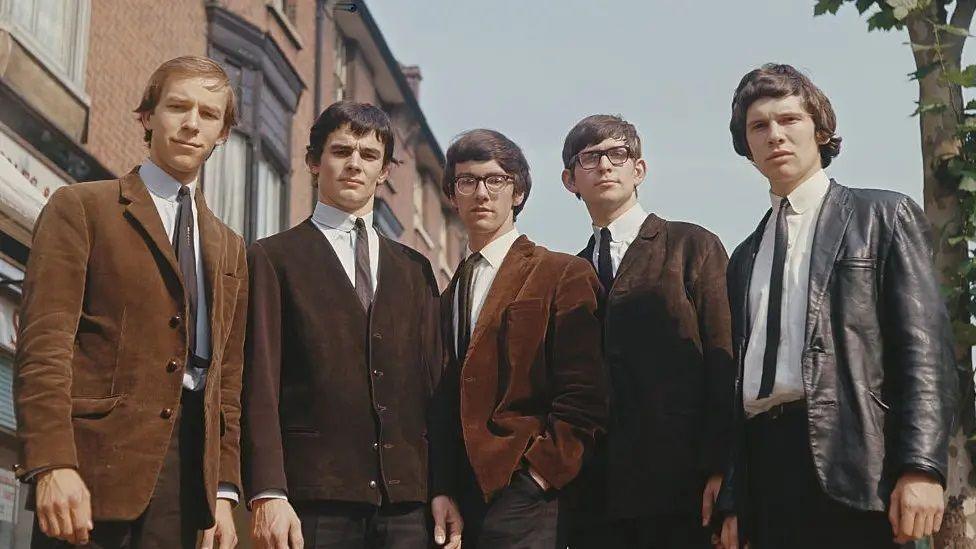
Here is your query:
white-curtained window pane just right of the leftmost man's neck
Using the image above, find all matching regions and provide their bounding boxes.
[203,132,247,235]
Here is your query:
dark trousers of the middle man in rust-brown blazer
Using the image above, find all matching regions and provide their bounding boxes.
[459,470,566,549]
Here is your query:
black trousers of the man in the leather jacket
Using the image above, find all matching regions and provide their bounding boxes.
[740,407,898,549]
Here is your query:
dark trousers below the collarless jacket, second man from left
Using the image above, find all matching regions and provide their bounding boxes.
[295,501,431,549]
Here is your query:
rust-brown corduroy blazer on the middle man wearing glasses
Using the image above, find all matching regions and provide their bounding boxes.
[431,236,608,499]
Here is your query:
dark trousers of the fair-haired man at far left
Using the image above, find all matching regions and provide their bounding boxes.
[31,390,213,549]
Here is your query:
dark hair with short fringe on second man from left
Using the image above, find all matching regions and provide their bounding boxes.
[305,101,394,166]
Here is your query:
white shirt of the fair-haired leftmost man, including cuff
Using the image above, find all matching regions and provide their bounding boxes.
[139,158,240,503]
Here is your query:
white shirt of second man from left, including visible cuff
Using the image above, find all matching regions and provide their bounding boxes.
[251,202,380,504]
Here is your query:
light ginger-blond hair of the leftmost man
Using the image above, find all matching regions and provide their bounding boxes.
[133,55,237,144]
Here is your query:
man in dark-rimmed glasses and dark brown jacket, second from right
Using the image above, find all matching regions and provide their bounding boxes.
[562,115,735,549]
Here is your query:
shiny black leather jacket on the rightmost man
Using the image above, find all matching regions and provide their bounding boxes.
[718,181,958,515]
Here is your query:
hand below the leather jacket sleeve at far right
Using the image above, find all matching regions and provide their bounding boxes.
[888,471,945,543]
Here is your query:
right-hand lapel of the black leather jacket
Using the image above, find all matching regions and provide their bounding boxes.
[805,179,854,342]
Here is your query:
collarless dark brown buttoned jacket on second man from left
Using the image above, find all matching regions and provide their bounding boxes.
[242,220,441,504]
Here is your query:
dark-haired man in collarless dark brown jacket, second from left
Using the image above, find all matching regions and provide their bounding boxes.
[243,101,441,549]
